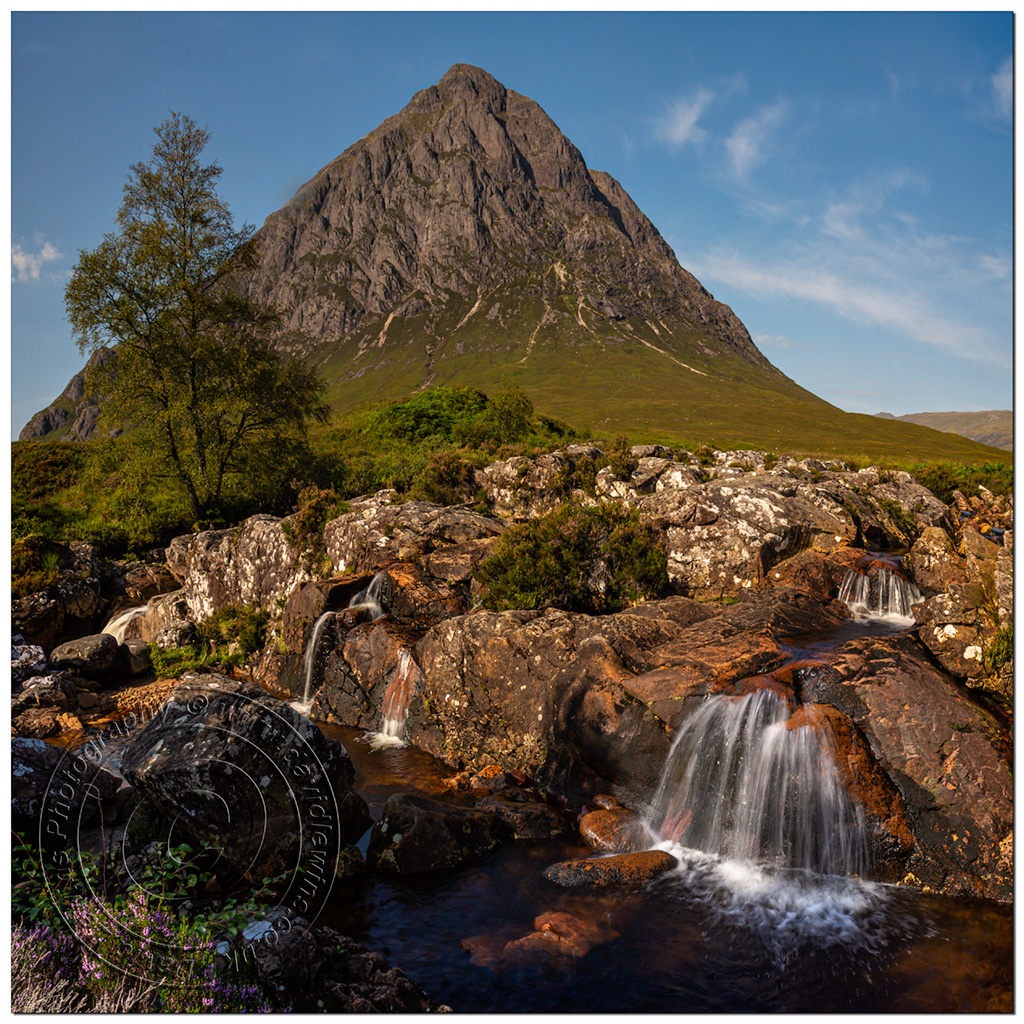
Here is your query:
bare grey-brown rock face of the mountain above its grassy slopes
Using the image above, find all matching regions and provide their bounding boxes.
[249,65,781,379]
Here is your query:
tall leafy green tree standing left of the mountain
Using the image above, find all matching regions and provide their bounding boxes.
[65,114,328,520]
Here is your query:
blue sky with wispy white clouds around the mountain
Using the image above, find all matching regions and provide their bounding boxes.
[11,12,1013,436]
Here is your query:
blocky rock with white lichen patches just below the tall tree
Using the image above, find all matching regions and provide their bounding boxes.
[168,515,311,623]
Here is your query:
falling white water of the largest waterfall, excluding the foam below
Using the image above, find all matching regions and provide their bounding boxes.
[647,690,867,876]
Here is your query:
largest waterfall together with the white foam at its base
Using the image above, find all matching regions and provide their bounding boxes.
[645,689,892,964]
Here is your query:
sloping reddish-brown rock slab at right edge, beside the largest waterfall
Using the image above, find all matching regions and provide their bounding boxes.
[805,636,1013,899]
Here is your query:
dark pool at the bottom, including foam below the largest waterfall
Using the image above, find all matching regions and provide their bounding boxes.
[319,728,1013,1013]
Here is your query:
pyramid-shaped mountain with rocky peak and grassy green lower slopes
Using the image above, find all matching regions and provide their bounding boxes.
[22,65,1011,462]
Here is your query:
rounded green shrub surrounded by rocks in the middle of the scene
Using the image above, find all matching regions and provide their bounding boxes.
[477,504,668,611]
